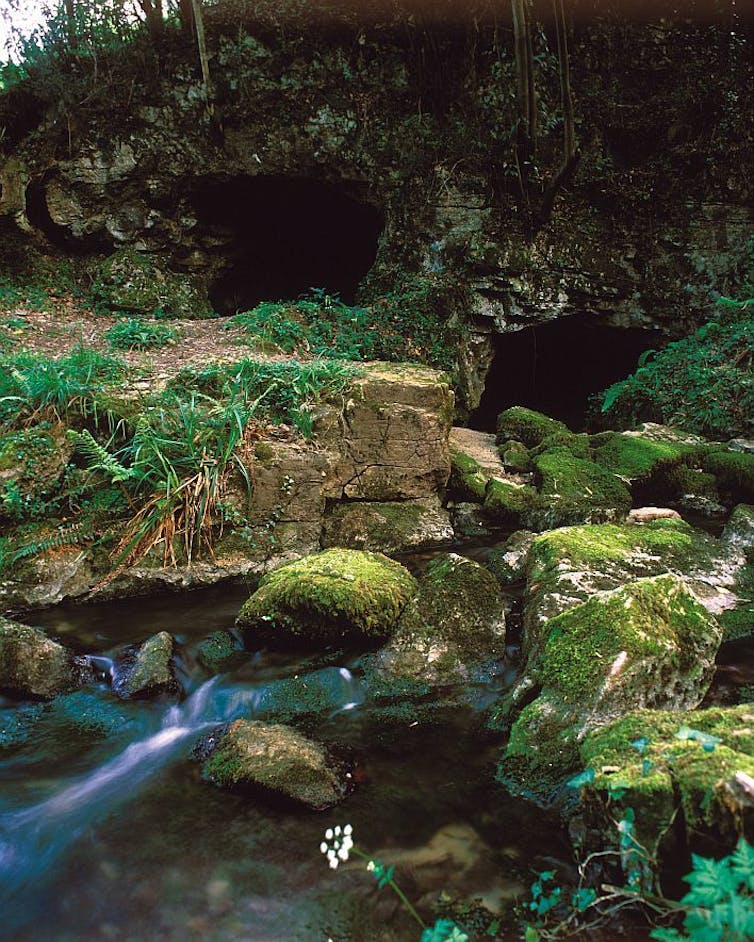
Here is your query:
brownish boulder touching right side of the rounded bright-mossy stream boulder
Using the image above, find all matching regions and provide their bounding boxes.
[378,553,505,683]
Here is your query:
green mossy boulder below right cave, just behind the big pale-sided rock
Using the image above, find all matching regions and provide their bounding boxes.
[534,446,631,528]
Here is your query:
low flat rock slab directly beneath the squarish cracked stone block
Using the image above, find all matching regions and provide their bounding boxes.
[322,497,454,554]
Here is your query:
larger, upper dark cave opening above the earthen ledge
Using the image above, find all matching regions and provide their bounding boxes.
[194,176,384,314]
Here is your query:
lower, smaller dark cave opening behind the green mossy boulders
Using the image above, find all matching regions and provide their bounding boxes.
[471,315,662,431]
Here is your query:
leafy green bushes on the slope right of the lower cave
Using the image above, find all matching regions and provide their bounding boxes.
[601,296,754,438]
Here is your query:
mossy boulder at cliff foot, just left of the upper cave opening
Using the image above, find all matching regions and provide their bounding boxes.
[92,248,210,318]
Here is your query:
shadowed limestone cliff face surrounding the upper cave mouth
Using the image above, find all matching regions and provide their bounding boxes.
[0,4,754,346]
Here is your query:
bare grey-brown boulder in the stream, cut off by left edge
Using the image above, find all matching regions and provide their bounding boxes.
[0,616,92,700]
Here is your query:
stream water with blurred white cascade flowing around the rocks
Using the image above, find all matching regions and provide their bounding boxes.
[0,587,568,942]
